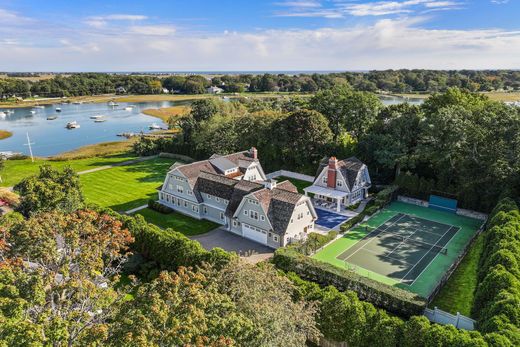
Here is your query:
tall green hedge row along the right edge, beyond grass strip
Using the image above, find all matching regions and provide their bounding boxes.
[473,198,520,346]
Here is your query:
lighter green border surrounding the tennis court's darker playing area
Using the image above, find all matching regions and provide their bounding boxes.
[313,202,482,297]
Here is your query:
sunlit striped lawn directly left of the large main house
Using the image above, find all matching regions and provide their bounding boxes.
[80,158,174,212]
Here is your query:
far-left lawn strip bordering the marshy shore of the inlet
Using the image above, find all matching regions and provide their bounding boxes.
[0,153,137,187]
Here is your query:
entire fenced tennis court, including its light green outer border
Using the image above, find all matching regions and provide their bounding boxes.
[313,202,482,297]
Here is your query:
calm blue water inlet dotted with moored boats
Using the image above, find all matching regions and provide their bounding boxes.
[0,101,180,156]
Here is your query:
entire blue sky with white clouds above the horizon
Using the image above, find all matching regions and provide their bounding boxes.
[0,0,520,71]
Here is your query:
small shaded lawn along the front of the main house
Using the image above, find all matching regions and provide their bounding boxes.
[136,208,218,236]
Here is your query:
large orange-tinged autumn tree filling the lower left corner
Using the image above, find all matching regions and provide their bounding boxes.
[0,210,132,346]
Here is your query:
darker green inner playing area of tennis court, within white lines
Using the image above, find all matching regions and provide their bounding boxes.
[338,213,460,285]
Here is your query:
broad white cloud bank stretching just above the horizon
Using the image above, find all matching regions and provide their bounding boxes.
[0,18,520,71]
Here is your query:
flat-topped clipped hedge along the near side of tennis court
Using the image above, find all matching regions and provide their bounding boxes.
[273,248,426,317]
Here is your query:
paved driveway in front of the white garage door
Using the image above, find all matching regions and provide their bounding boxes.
[191,228,274,263]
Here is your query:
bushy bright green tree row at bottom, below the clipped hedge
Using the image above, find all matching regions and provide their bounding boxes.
[287,273,494,347]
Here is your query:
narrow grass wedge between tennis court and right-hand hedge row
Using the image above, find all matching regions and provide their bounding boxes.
[430,234,484,317]
